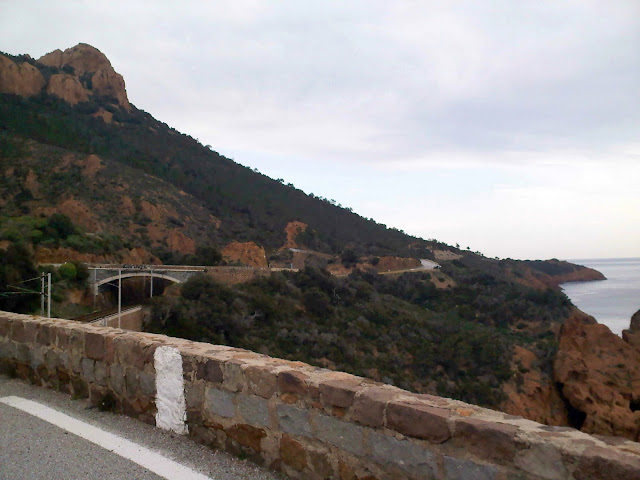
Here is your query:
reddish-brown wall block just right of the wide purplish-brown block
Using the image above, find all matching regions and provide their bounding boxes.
[453,418,518,463]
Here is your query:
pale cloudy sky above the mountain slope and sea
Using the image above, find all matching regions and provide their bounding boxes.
[0,0,640,259]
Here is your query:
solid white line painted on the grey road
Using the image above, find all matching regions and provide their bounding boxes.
[0,396,211,480]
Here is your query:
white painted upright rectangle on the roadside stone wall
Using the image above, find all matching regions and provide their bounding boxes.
[153,346,187,435]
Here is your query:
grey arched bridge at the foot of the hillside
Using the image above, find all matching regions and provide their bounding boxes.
[87,263,210,297]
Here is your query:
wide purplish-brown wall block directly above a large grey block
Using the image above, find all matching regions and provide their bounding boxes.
[386,401,451,443]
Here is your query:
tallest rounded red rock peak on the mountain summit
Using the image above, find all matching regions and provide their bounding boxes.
[38,43,131,109]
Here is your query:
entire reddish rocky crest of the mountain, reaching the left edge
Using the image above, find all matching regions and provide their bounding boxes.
[0,43,131,110]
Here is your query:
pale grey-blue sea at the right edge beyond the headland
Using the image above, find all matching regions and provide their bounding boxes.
[560,258,640,335]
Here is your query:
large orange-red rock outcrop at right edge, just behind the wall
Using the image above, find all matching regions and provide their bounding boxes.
[554,314,640,441]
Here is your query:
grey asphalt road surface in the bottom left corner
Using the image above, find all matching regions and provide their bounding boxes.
[0,375,283,480]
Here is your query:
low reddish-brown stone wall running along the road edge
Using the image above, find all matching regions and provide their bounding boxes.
[0,312,640,480]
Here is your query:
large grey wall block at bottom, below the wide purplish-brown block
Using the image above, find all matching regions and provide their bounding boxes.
[366,431,438,478]
